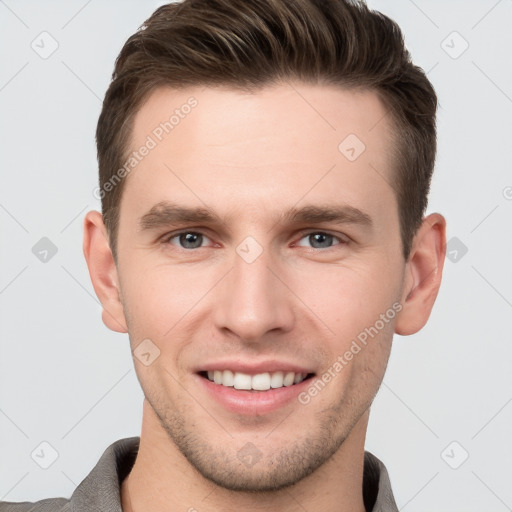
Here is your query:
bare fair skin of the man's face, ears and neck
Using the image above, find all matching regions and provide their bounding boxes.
[84,83,446,512]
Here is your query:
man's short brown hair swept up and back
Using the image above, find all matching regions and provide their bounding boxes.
[96,0,437,261]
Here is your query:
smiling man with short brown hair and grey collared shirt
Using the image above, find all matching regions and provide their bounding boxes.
[0,0,445,512]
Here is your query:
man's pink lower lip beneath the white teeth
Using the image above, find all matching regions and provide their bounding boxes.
[196,375,311,416]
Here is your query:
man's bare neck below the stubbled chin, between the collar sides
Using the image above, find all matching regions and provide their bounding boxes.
[121,400,369,512]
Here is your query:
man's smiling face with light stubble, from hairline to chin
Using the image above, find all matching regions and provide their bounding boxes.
[114,84,405,490]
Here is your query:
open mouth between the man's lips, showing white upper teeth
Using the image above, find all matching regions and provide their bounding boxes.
[199,370,315,391]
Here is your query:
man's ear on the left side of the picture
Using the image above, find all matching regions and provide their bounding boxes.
[83,210,128,333]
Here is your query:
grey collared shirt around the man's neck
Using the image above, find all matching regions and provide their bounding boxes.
[0,437,398,512]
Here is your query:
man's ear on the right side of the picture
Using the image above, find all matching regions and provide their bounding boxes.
[395,213,446,336]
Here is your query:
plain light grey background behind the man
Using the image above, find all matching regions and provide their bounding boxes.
[0,0,512,512]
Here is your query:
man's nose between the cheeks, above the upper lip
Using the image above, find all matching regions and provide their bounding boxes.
[214,243,294,344]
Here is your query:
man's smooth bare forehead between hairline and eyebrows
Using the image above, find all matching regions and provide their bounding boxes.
[122,83,396,228]
